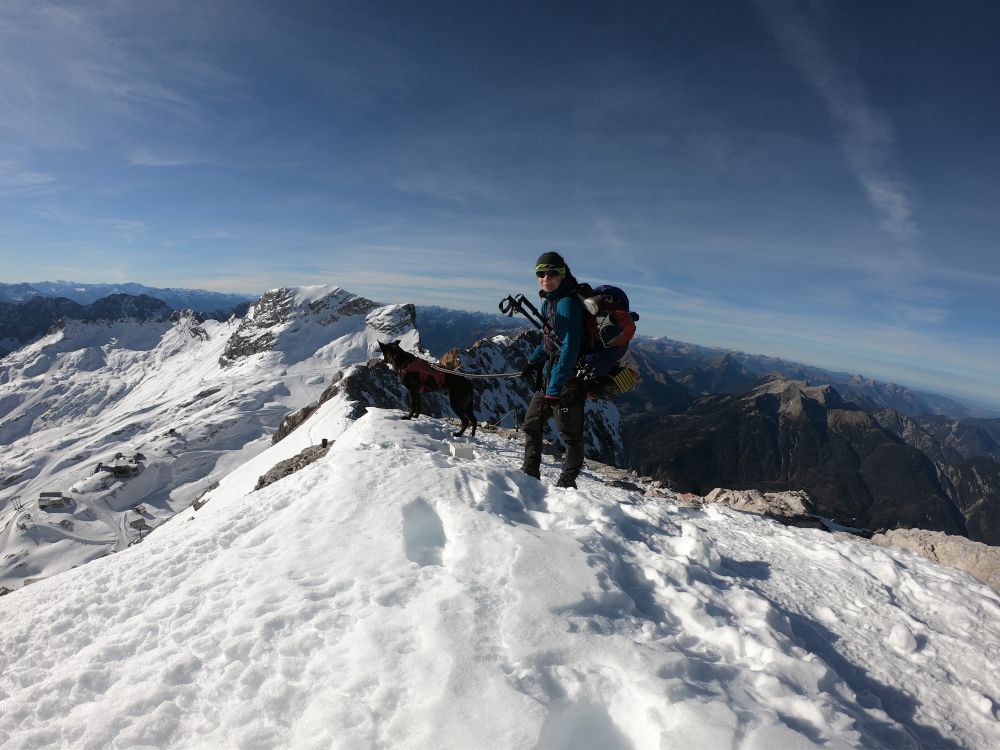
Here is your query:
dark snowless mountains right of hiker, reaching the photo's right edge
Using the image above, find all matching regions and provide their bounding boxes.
[623,377,1000,545]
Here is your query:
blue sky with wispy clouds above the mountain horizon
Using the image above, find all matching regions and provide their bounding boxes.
[0,0,1000,406]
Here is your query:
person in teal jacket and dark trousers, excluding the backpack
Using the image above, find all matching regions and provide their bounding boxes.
[521,253,587,487]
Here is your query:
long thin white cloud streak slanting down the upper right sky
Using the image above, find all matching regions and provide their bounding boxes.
[755,0,918,239]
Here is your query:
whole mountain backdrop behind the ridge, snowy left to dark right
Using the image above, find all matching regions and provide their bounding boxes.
[0,286,1000,600]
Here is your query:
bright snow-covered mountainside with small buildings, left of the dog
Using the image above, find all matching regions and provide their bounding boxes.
[0,286,419,593]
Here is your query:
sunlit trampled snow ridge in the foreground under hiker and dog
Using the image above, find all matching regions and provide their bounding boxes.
[0,412,1000,750]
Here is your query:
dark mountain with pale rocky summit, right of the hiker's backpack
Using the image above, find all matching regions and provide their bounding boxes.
[624,378,967,544]
